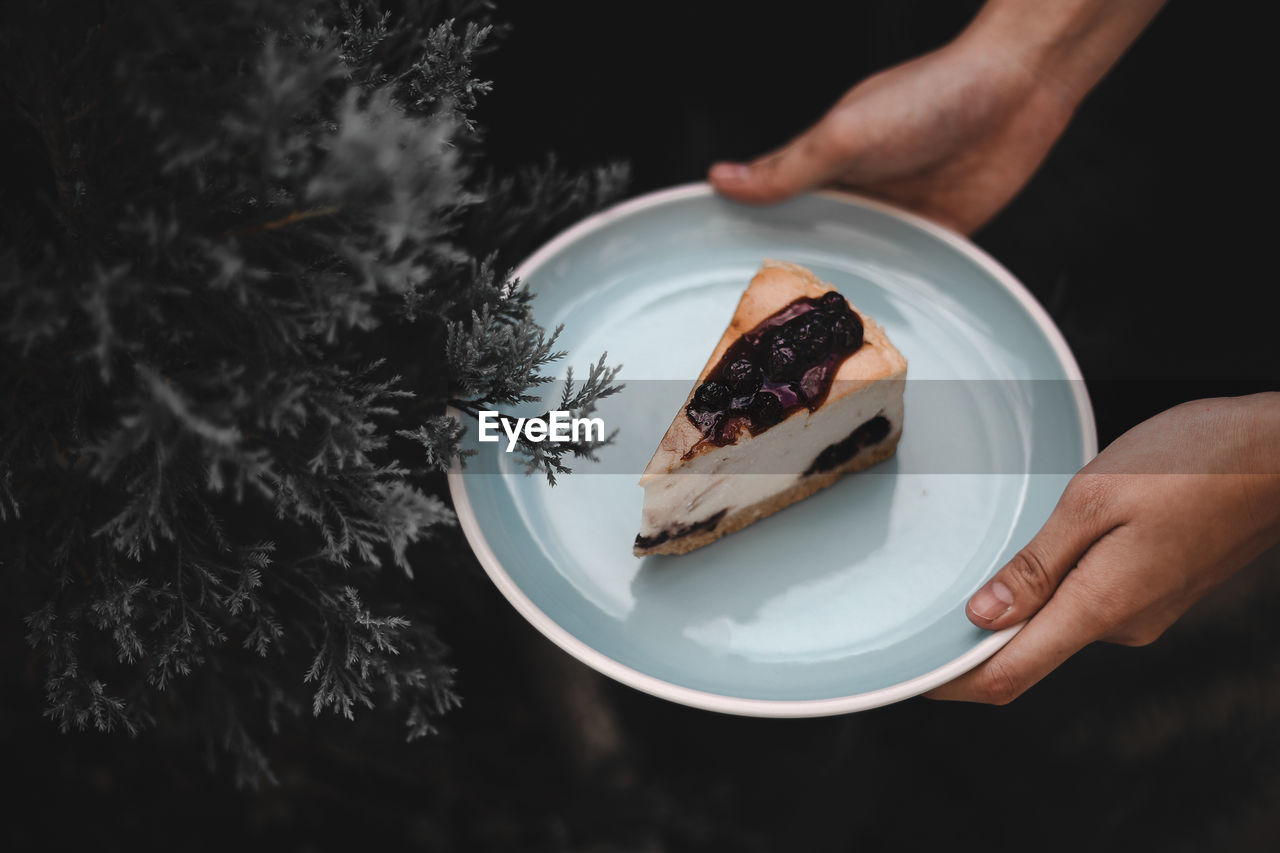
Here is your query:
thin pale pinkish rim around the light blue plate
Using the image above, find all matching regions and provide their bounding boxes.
[448,181,1098,717]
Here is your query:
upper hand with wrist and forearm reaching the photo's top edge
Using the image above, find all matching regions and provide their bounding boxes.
[708,0,1162,233]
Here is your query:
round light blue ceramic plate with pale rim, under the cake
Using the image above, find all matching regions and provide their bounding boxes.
[449,184,1097,716]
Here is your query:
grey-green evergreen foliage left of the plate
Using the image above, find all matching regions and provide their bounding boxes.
[0,0,625,781]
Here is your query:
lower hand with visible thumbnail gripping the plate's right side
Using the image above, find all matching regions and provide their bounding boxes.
[927,393,1280,704]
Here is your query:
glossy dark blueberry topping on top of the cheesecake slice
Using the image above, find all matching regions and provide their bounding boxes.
[685,291,863,459]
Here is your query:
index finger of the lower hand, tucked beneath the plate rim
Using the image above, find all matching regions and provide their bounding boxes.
[925,571,1108,704]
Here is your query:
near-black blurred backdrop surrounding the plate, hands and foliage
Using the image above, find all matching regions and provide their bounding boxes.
[0,0,1280,850]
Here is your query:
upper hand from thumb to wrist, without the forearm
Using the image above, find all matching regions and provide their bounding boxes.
[708,38,1074,233]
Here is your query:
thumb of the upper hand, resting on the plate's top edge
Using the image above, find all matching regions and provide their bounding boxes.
[707,122,845,204]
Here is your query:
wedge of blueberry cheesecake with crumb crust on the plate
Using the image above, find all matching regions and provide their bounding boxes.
[635,260,906,556]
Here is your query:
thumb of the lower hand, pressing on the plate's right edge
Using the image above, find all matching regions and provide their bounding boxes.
[965,474,1115,630]
